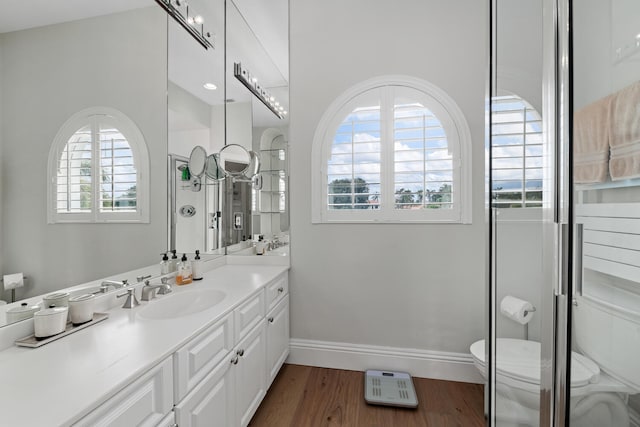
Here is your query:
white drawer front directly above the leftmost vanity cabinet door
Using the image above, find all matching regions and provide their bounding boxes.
[173,314,233,402]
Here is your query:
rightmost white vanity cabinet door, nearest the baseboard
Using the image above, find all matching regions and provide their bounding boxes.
[266,295,289,388]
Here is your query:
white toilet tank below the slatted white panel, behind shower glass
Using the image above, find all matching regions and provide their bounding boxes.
[573,296,640,392]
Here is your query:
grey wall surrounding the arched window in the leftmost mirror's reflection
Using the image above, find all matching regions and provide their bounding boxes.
[0,6,167,297]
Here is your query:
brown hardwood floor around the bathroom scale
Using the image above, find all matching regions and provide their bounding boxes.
[249,364,485,427]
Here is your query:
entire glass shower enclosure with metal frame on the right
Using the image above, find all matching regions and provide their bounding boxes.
[490,0,640,427]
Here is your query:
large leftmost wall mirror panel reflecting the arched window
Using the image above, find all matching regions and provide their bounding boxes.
[0,0,168,320]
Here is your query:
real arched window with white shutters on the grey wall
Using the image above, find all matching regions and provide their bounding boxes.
[313,76,471,223]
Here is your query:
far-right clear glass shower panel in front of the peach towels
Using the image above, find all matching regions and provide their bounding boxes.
[567,0,640,427]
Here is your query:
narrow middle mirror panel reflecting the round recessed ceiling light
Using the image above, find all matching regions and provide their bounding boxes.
[167,0,225,256]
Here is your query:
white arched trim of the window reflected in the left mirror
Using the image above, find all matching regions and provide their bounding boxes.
[47,107,150,224]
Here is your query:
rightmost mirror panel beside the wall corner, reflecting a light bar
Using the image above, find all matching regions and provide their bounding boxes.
[223,0,289,255]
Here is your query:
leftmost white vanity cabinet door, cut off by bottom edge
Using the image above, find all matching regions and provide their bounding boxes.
[174,355,237,427]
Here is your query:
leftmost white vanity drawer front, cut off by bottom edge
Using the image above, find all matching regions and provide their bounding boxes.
[75,358,173,427]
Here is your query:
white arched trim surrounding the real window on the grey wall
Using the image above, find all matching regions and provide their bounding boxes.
[311,75,472,224]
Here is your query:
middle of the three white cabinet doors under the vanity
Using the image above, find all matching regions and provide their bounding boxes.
[235,322,266,427]
